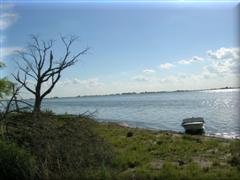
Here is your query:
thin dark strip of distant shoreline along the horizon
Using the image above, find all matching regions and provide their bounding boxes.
[44,87,240,99]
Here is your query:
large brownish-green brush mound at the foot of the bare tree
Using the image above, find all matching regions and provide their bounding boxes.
[4,113,113,179]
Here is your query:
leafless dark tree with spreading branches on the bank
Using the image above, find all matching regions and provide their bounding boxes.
[13,35,89,117]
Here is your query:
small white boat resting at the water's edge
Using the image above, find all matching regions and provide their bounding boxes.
[182,117,205,131]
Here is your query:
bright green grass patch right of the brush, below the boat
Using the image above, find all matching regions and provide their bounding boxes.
[96,123,240,179]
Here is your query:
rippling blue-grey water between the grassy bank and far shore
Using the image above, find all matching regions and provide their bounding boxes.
[43,89,240,137]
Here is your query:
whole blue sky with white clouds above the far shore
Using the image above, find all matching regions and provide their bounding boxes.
[0,0,240,97]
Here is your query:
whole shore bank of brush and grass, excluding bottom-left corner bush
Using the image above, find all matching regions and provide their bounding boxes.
[2,114,240,179]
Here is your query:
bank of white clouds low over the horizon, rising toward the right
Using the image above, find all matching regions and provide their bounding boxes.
[20,48,240,96]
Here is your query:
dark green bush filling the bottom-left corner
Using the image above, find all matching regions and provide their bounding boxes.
[0,140,37,180]
